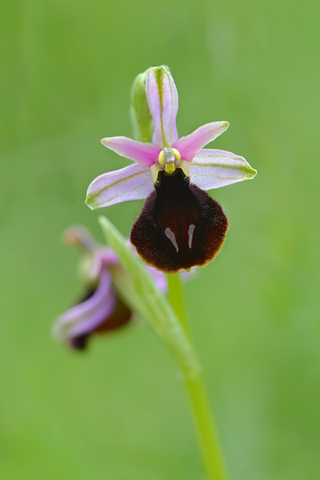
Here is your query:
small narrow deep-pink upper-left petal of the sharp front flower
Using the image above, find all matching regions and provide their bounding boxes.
[101,137,161,168]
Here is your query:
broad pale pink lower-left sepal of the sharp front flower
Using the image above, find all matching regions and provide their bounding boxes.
[86,163,153,210]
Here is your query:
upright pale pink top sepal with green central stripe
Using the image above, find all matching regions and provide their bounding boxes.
[146,67,178,149]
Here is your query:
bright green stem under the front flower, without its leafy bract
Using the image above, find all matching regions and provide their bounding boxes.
[167,275,227,480]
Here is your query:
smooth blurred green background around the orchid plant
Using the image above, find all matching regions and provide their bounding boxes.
[0,0,320,480]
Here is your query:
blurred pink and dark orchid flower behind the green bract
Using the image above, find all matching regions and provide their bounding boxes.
[53,226,167,350]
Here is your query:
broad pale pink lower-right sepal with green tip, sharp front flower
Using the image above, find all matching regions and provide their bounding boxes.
[189,149,257,190]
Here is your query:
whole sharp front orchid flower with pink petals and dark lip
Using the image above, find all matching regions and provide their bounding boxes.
[86,66,256,273]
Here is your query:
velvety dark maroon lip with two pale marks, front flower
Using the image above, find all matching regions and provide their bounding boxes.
[130,168,229,273]
